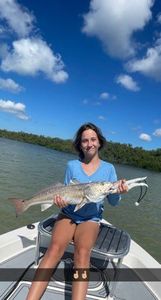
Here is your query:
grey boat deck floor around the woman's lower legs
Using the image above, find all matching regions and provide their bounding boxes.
[0,245,158,300]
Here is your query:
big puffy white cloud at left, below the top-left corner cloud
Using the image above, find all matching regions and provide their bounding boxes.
[1,38,68,83]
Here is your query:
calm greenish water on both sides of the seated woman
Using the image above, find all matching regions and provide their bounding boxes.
[0,138,161,262]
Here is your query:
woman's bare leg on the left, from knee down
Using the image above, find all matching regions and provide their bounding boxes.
[26,218,76,300]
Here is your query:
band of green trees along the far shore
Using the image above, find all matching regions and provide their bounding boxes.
[0,130,161,172]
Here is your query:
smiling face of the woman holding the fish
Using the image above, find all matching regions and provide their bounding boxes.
[81,129,100,158]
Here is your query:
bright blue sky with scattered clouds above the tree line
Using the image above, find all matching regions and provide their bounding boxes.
[0,0,161,149]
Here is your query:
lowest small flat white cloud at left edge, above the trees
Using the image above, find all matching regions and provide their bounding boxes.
[0,99,29,120]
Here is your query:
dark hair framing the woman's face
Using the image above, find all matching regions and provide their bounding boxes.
[73,123,106,159]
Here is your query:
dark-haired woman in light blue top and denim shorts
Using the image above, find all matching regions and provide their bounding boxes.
[27,123,127,300]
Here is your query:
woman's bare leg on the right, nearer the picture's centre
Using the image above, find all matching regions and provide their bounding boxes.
[72,221,99,300]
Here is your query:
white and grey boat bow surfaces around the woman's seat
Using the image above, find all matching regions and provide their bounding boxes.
[0,220,161,300]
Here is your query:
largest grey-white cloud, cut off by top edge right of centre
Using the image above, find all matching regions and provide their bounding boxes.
[82,0,154,58]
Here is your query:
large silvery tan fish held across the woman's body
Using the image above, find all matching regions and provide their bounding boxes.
[12,177,147,216]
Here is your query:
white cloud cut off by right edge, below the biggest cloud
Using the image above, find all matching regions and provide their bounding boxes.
[126,38,161,81]
